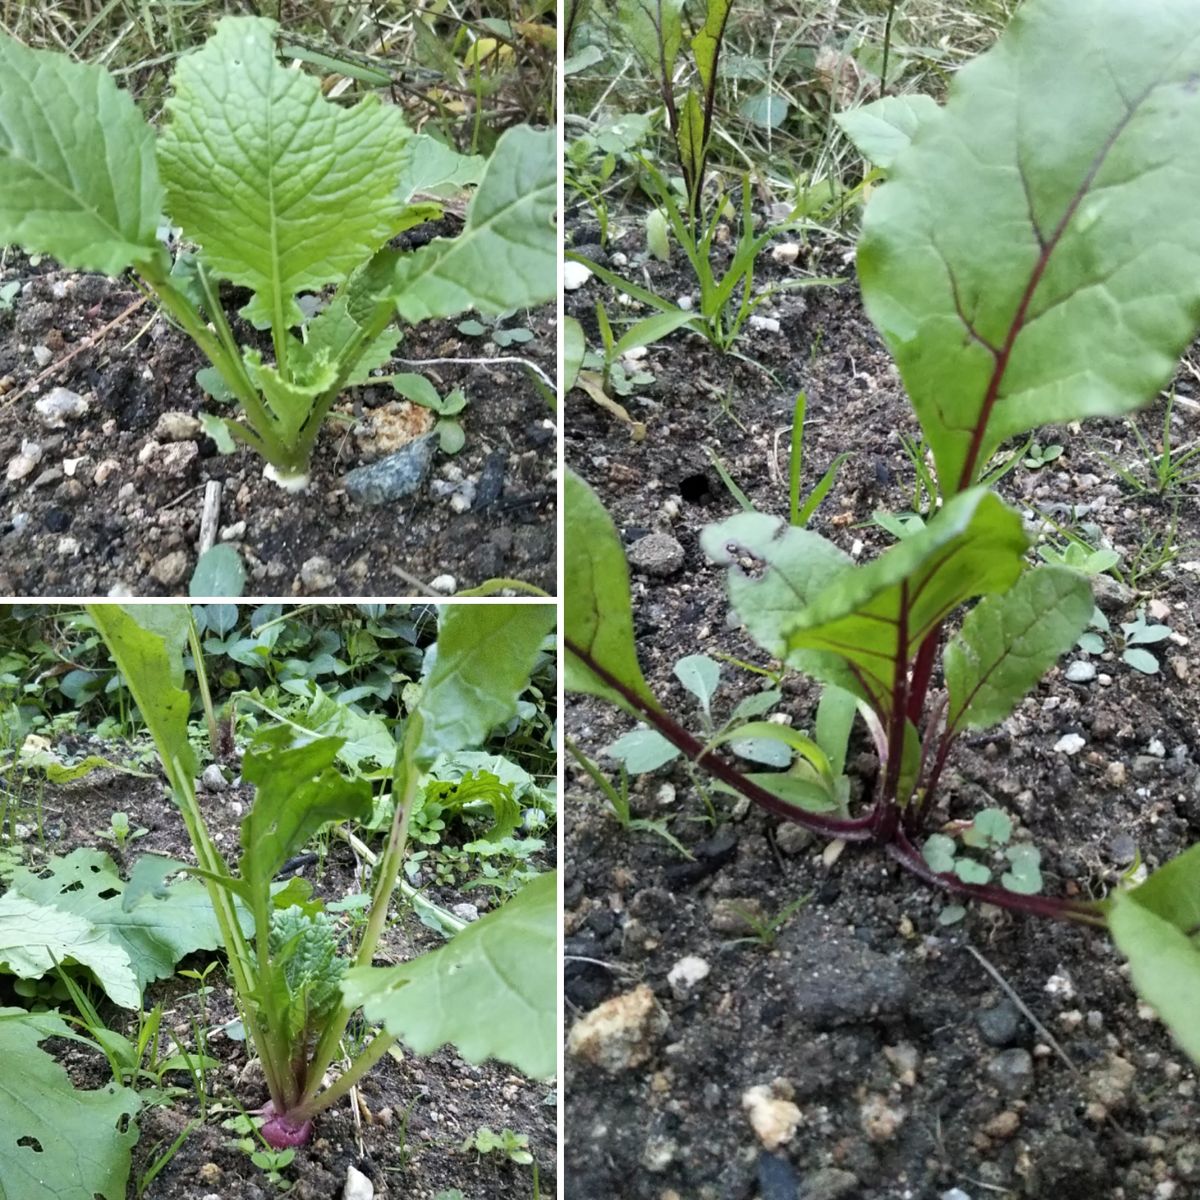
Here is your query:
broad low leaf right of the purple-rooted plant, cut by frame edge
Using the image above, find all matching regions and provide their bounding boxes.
[342,871,558,1079]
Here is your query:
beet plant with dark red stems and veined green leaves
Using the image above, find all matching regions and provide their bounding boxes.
[564,0,1200,1060]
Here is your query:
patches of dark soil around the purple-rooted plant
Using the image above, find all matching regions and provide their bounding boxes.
[0,758,557,1200]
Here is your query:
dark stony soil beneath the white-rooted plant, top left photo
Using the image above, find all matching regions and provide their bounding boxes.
[0,246,556,596]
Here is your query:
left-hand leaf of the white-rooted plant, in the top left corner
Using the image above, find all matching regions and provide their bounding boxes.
[0,34,162,275]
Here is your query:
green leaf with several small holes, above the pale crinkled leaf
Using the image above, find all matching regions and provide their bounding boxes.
[12,847,229,989]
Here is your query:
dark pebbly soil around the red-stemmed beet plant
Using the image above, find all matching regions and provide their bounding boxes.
[564,215,1200,1200]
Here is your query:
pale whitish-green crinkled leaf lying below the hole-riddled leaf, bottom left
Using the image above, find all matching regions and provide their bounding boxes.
[0,892,142,1008]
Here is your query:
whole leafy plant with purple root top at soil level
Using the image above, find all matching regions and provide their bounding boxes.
[89,605,556,1150]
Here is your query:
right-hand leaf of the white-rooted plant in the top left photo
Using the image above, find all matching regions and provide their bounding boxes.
[395,125,558,323]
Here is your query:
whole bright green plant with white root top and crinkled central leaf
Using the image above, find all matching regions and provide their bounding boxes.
[0,18,556,490]
